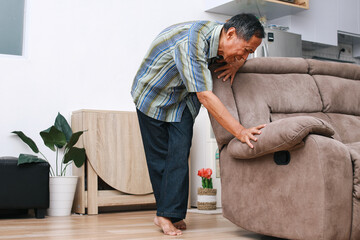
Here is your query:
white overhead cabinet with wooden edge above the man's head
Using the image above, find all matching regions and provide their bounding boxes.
[206,0,309,19]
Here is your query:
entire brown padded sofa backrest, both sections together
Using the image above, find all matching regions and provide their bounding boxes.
[211,58,360,147]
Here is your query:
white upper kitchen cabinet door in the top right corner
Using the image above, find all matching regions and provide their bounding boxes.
[338,0,360,34]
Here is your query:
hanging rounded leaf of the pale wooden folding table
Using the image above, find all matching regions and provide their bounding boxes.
[74,110,152,194]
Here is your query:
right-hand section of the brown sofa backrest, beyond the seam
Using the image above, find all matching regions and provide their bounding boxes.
[307,59,360,143]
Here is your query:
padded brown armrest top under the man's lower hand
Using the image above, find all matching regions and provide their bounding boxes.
[228,116,335,159]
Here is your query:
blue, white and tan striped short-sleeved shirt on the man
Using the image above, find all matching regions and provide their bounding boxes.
[131,21,223,122]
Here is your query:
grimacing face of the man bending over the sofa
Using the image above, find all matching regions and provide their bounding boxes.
[219,28,262,64]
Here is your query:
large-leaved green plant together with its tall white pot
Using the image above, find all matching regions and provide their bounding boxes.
[12,113,86,216]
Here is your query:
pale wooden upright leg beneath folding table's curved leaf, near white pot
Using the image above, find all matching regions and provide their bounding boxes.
[87,162,98,215]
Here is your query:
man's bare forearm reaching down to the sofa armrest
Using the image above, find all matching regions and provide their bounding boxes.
[197,91,244,138]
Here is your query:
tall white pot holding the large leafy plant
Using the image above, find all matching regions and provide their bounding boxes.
[47,176,78,216]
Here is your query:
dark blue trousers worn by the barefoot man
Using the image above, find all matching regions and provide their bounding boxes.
[137,107,194,222]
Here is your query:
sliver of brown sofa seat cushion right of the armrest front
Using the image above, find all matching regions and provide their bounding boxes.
[346,142,360,199]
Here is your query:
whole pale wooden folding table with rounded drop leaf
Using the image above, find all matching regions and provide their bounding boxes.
[71,110,155,214]
